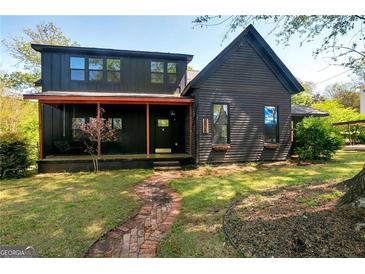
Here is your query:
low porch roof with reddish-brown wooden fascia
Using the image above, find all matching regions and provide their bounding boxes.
[23,91,194,105]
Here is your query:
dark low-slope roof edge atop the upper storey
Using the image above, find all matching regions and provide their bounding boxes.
[31,44,193,62]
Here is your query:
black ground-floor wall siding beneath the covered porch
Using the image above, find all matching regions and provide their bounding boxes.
[43,104,187,156]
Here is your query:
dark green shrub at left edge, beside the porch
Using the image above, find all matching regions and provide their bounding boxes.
[0,133,30,179]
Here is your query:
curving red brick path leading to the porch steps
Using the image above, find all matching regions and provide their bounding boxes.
[85,171,181,258]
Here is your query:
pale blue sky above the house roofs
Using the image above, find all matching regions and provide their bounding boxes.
[0,16,350,91]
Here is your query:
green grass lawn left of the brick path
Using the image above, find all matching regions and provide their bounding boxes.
[0,170,152,257]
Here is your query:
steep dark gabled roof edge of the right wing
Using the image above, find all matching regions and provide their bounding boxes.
[182,25,304,94]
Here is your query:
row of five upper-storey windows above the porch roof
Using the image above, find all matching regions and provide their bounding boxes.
[70,57,178,84]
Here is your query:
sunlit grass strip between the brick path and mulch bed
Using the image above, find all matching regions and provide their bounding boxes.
[158,151,365,257]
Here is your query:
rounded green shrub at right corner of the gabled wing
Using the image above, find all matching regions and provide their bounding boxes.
[294,117,343,160]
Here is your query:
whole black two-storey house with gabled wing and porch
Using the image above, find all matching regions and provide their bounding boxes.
[24,26,303,172]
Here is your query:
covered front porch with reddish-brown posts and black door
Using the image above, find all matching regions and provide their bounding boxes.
[24,92,193,172]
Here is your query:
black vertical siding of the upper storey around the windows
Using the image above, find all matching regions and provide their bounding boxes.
[42,52,187,94]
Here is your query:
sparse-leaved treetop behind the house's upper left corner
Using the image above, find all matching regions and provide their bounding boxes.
[0,22,79,90]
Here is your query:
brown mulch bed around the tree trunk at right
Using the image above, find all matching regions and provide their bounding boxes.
[224,183,365,257]
